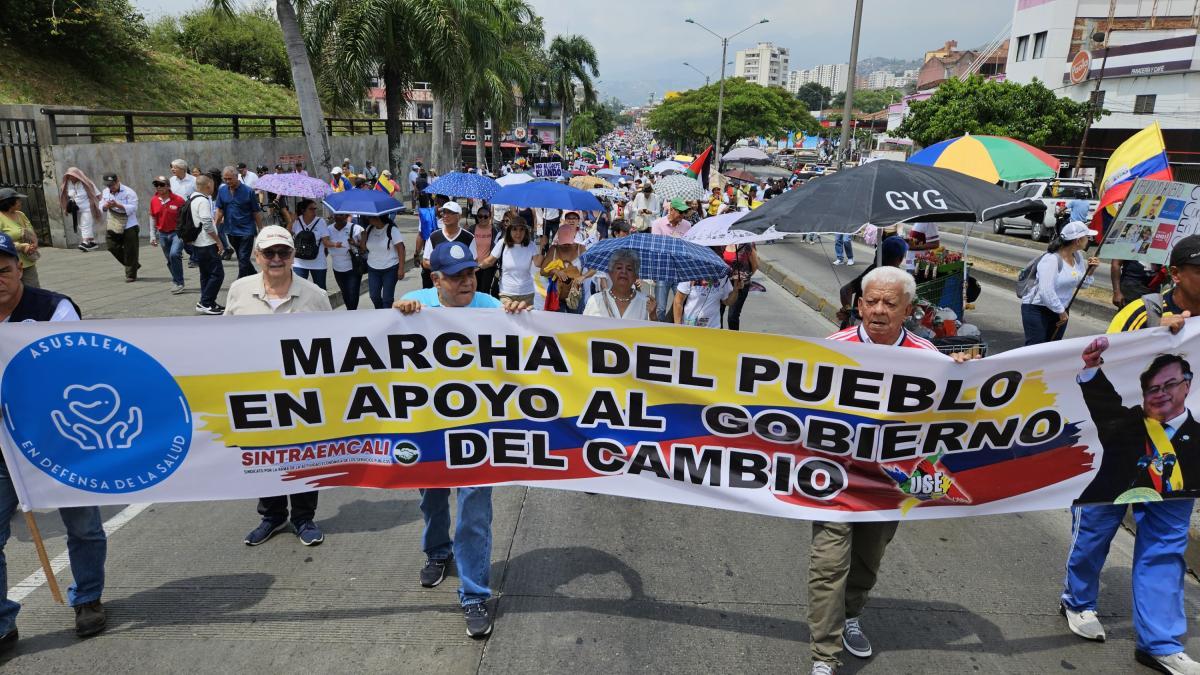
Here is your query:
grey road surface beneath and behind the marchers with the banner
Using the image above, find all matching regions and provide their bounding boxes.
[2,228,1200,675]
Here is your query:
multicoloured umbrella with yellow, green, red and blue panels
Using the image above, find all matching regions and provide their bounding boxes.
[908,133,1058,183]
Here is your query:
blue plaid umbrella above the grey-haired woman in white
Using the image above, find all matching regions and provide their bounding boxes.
[580,233,730,283]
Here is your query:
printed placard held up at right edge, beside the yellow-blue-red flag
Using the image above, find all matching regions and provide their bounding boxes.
[1097,179,1200,264]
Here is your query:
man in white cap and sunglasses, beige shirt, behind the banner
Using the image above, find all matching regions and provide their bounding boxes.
[224,225,334,546]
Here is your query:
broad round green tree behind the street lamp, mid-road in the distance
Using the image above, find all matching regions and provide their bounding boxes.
[648,77,820,154]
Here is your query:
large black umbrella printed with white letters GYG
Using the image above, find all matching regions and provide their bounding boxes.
[732,160,1045,233]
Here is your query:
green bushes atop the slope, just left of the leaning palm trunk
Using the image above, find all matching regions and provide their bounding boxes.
[150,4,292,86]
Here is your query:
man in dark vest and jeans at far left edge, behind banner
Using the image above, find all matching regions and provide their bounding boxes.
[0,234,108,655]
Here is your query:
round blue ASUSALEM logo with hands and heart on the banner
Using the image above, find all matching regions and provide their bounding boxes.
[0,333,192,494]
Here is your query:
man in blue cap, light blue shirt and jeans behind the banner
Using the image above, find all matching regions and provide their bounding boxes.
[394,240,529,638]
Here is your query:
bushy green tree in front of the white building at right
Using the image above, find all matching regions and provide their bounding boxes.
[892,76,1104,147]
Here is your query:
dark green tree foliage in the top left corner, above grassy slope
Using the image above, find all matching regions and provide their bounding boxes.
[0,0,149,63]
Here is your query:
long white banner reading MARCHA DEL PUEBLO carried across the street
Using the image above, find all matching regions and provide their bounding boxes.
[0,309,1200,520]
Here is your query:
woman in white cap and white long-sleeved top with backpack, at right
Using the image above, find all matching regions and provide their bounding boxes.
[1021,221,1100,345]
